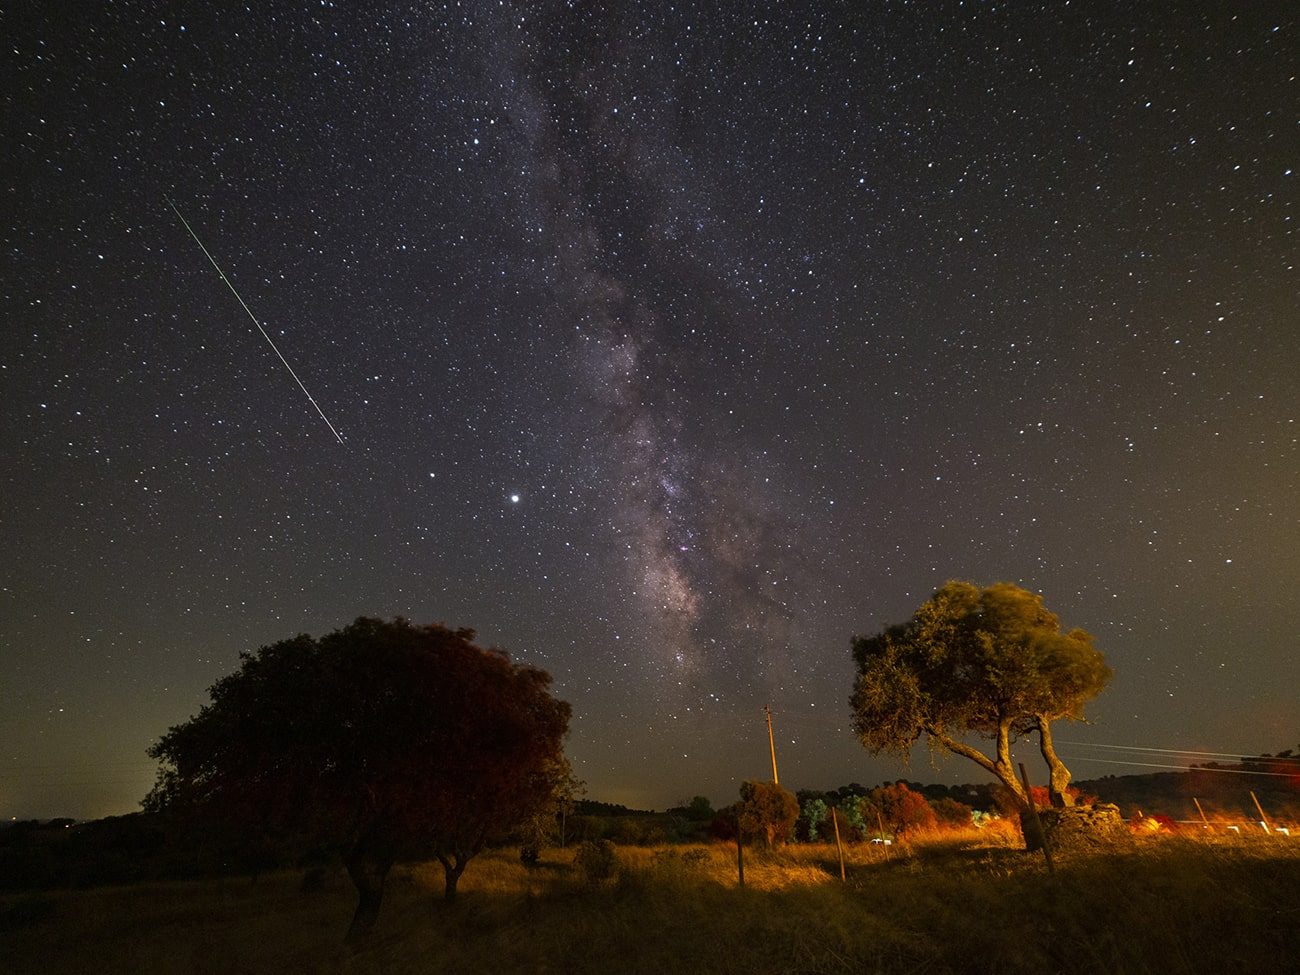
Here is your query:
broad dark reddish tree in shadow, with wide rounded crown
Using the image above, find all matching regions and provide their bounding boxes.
[144,618,569,939]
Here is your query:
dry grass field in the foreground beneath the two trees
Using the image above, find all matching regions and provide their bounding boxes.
[0,836,1300,975]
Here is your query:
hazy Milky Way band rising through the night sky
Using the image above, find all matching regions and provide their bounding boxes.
[485,7,792,672]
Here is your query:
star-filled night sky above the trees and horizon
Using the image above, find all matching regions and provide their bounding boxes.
[0,0,1300,819]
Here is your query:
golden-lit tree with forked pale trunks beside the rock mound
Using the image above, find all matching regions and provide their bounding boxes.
[852,582,1110,805]
